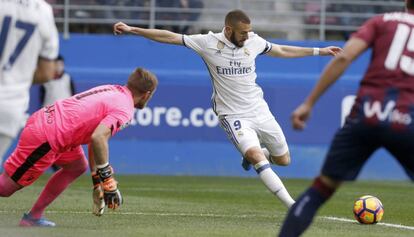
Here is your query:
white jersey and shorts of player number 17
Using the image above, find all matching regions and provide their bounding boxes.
[0,0,59,137]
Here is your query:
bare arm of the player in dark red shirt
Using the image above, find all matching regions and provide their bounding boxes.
[291,37,368,130]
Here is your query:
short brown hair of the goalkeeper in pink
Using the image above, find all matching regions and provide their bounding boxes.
[127,68,158,94]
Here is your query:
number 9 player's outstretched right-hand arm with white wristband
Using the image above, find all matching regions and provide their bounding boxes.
[267,44,342,58]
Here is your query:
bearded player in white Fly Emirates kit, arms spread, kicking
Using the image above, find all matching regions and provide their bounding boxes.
[114,10,341,207]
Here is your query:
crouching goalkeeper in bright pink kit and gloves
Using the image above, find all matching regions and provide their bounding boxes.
[0,68,158,227]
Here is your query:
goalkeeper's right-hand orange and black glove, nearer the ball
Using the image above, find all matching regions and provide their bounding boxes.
[97,165,123,210]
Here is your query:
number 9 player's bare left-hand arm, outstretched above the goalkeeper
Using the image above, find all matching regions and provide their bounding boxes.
[114,22,183,45]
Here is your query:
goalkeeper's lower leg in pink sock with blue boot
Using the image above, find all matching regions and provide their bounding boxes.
[20,157,88,226]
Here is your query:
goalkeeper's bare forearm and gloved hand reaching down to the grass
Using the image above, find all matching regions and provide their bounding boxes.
[91,124,123,209]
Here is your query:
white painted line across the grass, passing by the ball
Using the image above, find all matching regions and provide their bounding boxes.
[0,210,414,231]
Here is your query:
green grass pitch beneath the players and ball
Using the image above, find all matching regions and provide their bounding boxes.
[0,175,414,237]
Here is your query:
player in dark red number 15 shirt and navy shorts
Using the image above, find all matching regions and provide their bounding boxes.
[280,0,414,236]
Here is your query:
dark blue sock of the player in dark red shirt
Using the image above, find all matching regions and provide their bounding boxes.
[279,178,335,237]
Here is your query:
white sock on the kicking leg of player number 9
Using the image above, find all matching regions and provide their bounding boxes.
[254,160,295,208]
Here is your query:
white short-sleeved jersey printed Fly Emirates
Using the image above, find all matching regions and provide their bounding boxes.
[183,29,272,116]
